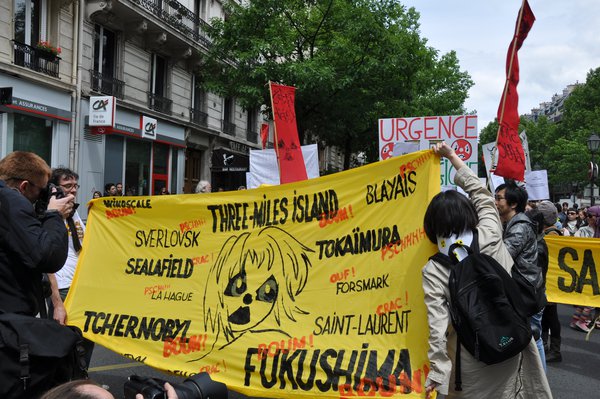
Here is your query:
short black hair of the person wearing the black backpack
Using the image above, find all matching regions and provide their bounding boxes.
[423,190,479,244]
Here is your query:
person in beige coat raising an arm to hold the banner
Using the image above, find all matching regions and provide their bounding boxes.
[423,143,552,399]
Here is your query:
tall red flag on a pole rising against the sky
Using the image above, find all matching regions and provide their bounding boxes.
[494,0,535,181]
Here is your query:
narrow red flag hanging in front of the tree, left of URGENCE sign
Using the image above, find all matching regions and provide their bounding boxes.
[269,82,308,184]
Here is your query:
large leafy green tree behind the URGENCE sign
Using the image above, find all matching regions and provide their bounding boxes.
[200,0,472,168]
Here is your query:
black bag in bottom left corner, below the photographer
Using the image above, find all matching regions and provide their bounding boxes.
[0,313,87,399]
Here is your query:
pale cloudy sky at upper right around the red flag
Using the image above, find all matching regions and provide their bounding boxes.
[398,0,600,134]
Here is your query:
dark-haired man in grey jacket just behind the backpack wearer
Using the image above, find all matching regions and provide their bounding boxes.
[494,180,546,369]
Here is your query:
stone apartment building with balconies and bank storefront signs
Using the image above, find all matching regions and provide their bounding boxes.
[0,0,262,219]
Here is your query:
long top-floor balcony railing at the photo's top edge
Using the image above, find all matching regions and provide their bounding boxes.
[131,0,210,47]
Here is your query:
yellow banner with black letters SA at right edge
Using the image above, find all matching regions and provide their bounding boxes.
[544,236,600,307]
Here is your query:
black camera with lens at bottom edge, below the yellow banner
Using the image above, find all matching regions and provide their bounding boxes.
[123,373,228,399]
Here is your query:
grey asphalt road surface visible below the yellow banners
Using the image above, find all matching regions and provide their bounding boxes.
[90,305,600,399]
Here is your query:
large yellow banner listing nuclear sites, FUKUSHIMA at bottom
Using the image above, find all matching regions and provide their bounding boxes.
[66,150,440,398]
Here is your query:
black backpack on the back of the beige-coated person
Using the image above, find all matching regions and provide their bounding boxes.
[430,232,531,391]
